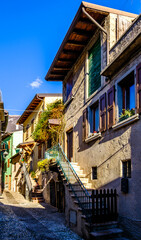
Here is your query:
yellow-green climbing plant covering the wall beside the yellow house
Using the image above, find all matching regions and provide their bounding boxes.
[33,100,64,144]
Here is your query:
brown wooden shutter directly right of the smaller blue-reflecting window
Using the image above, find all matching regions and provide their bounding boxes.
[100,93,106,132]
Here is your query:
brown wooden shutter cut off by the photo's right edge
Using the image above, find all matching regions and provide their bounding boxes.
[136,63,141,113]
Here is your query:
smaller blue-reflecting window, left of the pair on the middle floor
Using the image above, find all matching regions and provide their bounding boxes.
[89,103,99,133]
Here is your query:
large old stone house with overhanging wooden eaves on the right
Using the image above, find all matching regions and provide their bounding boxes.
[46,2,141,239]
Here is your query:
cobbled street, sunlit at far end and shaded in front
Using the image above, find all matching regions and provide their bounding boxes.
[0,191,82,240]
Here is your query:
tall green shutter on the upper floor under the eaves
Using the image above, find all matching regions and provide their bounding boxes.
[88,38,101,96]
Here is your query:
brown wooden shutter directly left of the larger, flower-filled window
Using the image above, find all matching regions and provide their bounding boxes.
[107,86,115,129]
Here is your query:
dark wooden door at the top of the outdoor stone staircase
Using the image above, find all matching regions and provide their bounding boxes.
[67,130,73,162]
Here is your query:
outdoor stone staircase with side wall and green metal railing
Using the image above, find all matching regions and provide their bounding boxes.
[47,144,127,240]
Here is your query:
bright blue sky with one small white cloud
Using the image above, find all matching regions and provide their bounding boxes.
[0,0,141,115]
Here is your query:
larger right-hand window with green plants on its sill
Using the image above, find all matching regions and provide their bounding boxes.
[118,72,135,119]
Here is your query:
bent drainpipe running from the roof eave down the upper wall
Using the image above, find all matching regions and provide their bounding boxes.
[82,7,109,65]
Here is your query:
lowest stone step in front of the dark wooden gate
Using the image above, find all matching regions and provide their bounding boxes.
[90,228,123,239]
